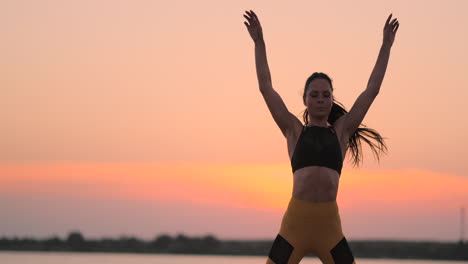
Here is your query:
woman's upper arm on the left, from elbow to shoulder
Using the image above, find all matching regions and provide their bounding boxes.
[261,88,302,137]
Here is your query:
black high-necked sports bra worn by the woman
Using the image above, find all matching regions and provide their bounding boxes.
[291,126,343,175]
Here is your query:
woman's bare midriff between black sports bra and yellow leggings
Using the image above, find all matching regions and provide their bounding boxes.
[293,166,340,202]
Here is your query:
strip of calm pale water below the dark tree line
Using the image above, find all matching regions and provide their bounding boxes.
[0,251,468,264]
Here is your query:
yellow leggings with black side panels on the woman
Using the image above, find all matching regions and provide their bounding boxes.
[266,197,355,264]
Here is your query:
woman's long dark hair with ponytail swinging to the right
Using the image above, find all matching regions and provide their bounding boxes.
[302,72,387,166]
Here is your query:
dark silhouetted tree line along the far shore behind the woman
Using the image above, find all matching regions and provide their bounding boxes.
[0,231,468,260]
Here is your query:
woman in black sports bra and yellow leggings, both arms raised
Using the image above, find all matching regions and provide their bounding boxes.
[244,10,399,264]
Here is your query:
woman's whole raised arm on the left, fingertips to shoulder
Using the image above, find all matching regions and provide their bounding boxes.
[244,10,302,137]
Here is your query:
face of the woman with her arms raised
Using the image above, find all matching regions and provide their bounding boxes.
[305,79,333,119]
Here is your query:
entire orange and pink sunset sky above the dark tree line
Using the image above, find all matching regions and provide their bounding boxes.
[0,0,468,241]
